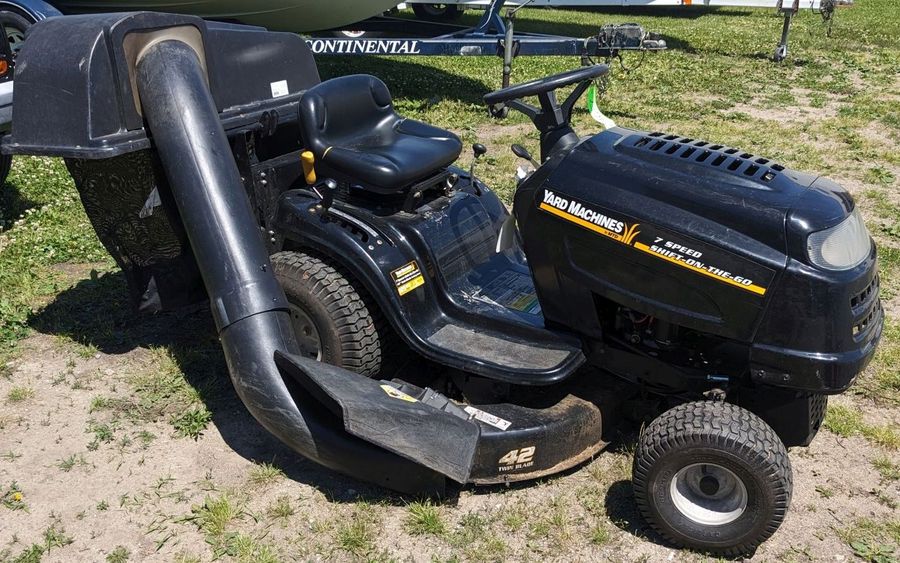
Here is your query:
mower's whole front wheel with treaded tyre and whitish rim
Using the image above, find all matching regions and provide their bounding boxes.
[633,401,792,556]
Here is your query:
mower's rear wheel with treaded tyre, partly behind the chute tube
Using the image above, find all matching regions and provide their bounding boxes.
[271,252,396,377]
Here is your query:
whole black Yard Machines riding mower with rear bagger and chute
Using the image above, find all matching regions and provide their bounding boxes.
[3,13,883,555]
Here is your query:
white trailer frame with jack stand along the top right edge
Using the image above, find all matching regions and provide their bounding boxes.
[405,0,853,62]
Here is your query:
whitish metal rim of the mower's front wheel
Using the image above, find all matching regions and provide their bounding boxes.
[669,463,747,526]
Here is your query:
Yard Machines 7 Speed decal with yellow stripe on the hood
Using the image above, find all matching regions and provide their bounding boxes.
[538,190,772,296]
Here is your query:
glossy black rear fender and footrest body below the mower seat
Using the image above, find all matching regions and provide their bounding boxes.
[274,189,584,386]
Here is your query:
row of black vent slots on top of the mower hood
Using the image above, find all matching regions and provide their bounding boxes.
[622,132,784,182]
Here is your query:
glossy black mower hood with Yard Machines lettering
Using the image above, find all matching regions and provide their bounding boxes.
[515,128,881,391]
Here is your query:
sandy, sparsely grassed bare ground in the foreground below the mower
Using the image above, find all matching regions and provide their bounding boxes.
[0,324,900,561]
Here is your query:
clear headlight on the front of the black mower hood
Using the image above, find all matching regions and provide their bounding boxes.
[806,209,872,270]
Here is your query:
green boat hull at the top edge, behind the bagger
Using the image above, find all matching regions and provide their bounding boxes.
[54,0,397,32]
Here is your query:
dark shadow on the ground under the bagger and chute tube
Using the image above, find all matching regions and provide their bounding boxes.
[30,271,428,505]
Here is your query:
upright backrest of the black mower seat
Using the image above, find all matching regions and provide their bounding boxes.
[300,74,401,158]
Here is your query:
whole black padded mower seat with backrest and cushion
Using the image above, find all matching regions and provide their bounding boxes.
[300,74,462,194]
